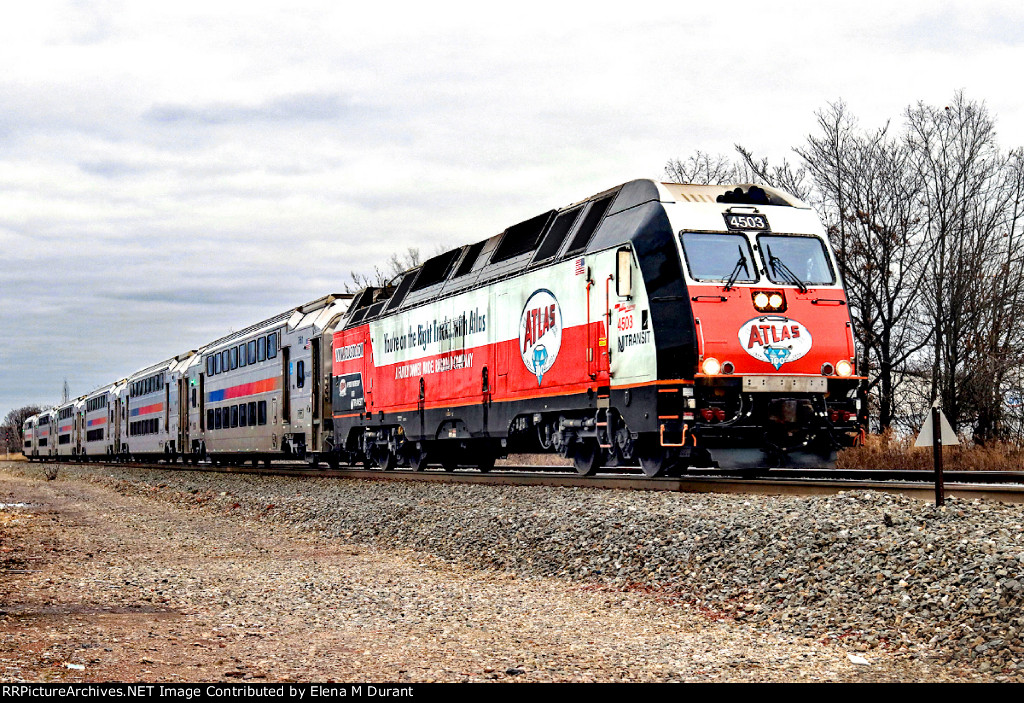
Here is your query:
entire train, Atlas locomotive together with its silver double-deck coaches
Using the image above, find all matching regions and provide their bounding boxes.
[24,180,862,476]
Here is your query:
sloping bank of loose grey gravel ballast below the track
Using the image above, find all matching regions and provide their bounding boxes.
[16,467,1024,673]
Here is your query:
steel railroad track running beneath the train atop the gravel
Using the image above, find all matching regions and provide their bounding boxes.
[28,463,1024,502]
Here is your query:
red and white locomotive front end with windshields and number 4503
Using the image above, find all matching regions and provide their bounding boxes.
[630,184,860,469]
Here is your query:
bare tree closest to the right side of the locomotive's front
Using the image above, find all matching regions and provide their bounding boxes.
[796,102,931,430]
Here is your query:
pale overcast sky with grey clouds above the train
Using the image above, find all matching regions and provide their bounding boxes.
[0,0,1024,416]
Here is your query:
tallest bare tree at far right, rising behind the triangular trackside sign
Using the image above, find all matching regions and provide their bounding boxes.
[906,93,1024,441]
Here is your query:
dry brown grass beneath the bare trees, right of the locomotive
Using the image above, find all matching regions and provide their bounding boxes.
[836,432,1024,471]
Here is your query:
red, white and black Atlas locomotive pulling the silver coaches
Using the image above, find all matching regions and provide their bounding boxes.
[333,180,860,476]
